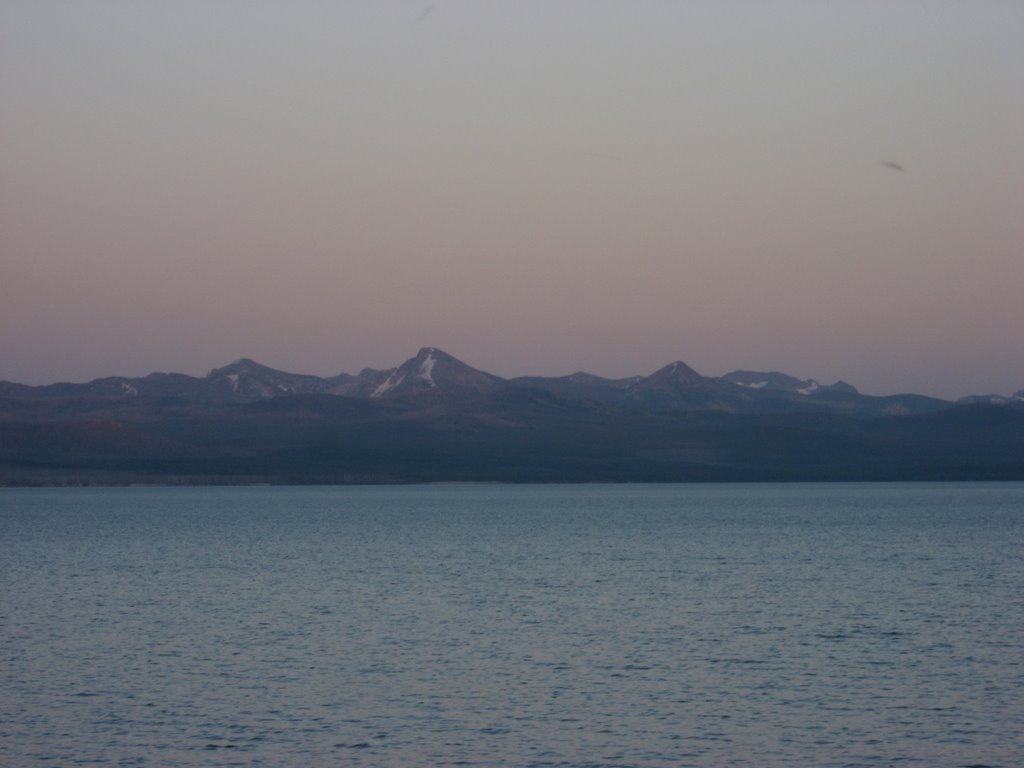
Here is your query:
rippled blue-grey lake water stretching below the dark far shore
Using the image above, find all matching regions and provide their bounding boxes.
[0,484,1024,766]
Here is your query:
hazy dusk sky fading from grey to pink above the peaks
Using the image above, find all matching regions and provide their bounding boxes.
[0,0,1024,397]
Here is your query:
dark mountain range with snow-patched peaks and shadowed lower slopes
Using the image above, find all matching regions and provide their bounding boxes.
[0,347,1024,484]
